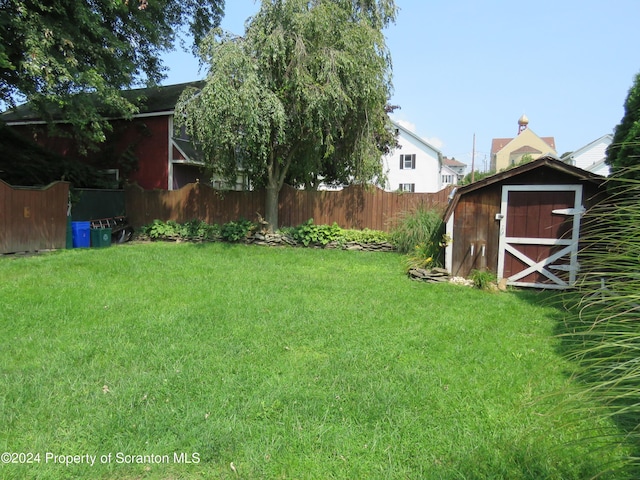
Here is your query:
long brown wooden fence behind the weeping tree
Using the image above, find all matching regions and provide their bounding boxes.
[125,183,452,231]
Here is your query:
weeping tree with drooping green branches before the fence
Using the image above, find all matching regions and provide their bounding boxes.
[176,0,396,228]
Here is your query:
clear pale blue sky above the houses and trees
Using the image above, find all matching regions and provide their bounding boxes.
[164,0,640,170]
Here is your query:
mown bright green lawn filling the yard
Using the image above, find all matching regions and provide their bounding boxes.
[0,243,623,480]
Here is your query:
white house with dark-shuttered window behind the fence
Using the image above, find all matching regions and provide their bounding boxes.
[382,121,458,193]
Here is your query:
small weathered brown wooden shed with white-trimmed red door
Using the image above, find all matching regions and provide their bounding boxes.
[444,157,605,289]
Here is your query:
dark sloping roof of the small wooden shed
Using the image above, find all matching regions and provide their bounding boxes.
[444,155,606,222]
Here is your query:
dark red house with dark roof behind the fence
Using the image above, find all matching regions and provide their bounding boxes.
[0,82,243,190]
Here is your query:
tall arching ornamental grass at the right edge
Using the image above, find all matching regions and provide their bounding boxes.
[561,168,640,478]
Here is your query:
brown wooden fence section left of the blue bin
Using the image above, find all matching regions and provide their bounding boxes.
[0,180,69,254]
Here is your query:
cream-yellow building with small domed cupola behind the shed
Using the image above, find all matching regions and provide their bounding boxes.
[491,115,558,172]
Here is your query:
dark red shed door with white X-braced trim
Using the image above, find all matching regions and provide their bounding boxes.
[498,185,584,289]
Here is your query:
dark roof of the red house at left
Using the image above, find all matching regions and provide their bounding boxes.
[0,81,204,124]
